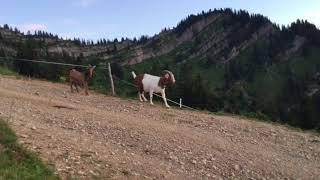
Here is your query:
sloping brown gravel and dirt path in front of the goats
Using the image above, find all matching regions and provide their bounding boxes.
[0,76,320,179]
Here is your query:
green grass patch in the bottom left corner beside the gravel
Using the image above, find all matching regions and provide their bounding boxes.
[0,119,59,180]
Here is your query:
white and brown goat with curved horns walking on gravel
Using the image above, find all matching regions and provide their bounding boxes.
[131,70,176,108]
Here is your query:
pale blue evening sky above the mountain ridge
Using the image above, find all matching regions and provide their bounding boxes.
[0,0,320,40]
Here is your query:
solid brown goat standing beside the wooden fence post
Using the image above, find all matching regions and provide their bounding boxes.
[69,64,96,95]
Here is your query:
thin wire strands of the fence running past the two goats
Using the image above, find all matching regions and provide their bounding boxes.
[0,57,198,111]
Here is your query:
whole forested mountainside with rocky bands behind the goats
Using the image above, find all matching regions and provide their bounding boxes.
[0,8,320,131]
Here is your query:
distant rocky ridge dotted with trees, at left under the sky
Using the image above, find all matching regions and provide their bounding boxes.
[0,24,132,58]
